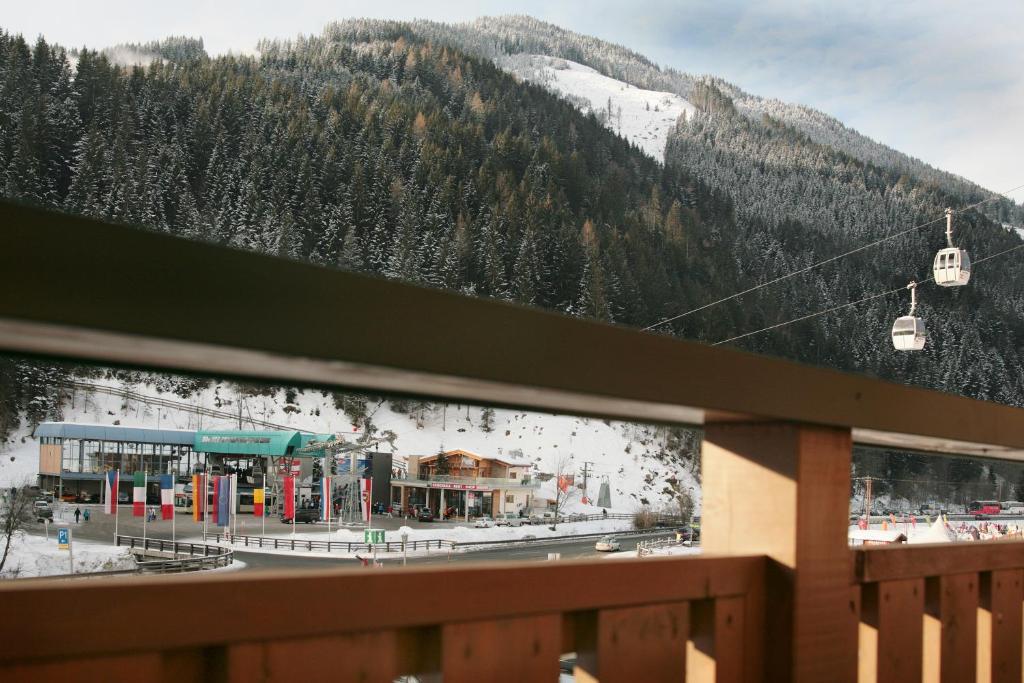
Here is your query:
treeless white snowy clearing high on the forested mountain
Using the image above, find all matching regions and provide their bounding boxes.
[499,54,695,161]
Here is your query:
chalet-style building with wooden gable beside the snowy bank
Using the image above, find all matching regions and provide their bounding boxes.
[391,449,537,521]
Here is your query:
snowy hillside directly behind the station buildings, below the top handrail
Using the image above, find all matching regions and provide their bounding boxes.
[0,379,700,512]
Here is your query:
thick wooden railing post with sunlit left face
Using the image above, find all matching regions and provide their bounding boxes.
[701,422,857,682]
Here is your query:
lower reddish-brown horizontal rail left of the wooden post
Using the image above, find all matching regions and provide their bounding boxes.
[0,557,765,663]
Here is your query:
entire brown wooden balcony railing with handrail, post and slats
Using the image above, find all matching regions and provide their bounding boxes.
[0,204,1024,683]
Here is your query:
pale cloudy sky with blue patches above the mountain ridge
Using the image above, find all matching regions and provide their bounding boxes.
[0,0,1024,197]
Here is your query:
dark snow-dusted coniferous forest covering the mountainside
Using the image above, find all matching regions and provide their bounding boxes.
[0,23,1024,496]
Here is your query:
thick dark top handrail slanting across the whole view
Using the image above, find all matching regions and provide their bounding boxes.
[0,203,1024,459]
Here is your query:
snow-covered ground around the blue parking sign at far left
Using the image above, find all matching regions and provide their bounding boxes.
[0,529,135,579]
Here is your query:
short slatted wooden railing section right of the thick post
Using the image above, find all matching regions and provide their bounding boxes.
[853,541,1024,681]
